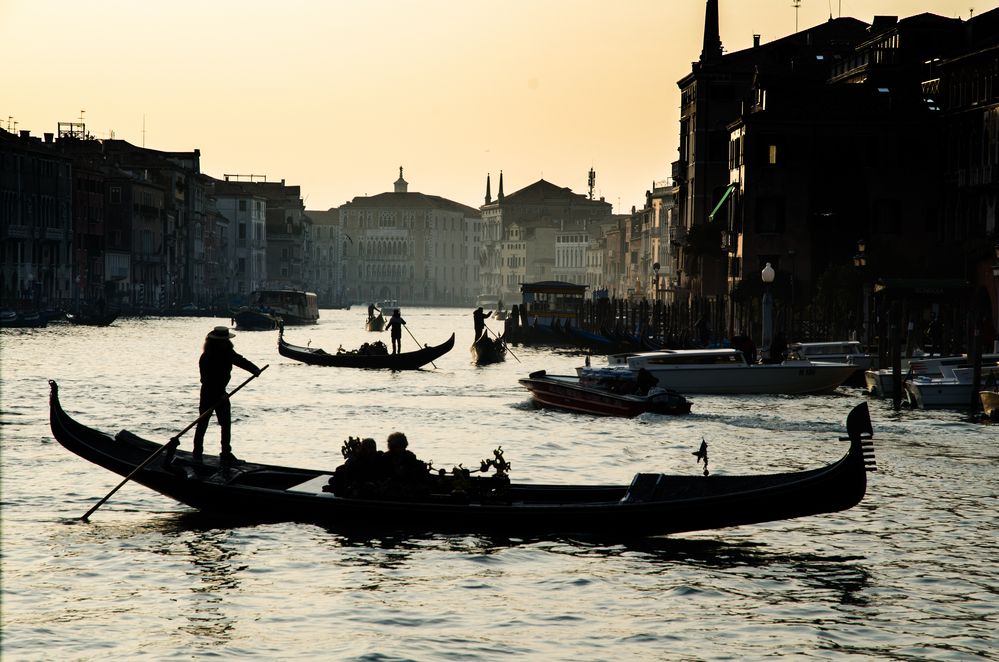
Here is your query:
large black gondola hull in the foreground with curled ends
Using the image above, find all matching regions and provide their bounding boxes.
[49,382,875,537]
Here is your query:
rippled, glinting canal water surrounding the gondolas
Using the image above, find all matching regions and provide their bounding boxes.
[0,308,999,660]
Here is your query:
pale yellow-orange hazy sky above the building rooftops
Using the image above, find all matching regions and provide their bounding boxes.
[0,0,980,213]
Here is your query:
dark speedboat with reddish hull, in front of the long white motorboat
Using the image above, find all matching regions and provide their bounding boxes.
[518,370,691,418]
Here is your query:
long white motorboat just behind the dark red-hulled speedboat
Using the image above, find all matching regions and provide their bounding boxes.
[576,349,856,395]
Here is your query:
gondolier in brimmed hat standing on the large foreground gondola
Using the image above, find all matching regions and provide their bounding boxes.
[188,326,260,466]
